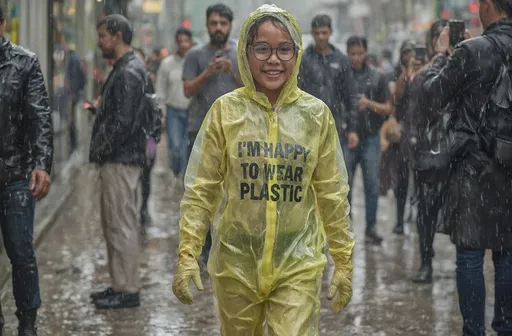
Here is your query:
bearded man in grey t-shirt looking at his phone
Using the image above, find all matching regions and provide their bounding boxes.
[183,4,243,263]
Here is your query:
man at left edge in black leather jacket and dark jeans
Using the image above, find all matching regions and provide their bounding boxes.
[0,8,53,336]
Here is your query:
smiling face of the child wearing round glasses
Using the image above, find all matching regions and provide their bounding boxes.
[248,21,297,97]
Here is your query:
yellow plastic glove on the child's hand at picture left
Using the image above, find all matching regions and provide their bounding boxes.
[172,257,204,304]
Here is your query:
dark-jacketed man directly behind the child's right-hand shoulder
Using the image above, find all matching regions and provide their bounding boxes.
[299,14,359,149]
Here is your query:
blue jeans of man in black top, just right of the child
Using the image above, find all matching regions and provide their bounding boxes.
[343,136,380,234]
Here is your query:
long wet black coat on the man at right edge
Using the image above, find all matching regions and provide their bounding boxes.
[423,20,512,249]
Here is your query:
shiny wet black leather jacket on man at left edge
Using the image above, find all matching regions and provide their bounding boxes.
[0,40,53,187]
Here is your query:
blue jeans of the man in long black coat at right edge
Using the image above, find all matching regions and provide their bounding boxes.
[456,248,512,336]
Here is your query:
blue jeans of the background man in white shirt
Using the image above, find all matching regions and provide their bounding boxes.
[166,106,188,175]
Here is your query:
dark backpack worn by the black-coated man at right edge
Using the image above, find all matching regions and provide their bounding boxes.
[477,36,512,172]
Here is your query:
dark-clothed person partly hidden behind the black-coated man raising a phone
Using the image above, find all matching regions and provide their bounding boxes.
[397,20,448,283]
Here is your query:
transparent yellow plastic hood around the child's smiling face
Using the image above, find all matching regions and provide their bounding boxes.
[238,5,302,107]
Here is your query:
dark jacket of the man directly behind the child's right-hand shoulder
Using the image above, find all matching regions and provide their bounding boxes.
[299,45,357,135]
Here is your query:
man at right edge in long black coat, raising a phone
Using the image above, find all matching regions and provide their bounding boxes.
[423,0,512,336]
